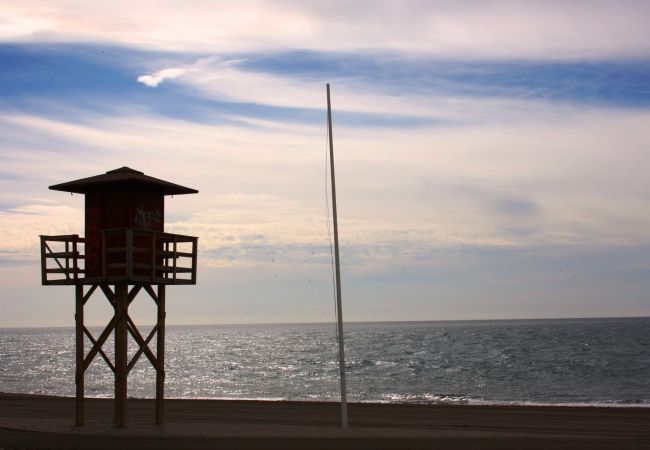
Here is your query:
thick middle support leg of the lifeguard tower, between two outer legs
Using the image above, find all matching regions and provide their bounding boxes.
[114,284,129,427]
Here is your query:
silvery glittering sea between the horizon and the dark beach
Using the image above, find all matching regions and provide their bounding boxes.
[0,318,650,407]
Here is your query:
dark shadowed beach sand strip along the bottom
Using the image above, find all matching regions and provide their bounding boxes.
[0,394,650,449]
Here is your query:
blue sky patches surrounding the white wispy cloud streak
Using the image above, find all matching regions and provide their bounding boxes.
[0,45,650,127]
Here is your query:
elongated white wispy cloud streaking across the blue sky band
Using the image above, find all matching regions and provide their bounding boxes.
[138,56,612,126]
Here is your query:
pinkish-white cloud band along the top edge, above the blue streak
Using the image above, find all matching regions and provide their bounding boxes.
[0,0,650,59]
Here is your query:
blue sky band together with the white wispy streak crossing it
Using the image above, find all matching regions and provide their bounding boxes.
[0,46,650,128]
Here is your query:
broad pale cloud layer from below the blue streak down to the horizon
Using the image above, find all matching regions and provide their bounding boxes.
[0,100,650,323]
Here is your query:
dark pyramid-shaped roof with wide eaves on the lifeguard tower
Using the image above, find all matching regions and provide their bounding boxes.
[50,167,199,195]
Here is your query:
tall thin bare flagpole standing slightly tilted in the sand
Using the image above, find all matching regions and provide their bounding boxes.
[327,83,348,429]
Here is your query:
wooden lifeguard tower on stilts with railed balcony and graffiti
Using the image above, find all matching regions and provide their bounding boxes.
[40,167,198,427]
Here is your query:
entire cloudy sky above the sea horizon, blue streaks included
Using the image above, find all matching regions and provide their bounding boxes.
[0,0,650,327]
